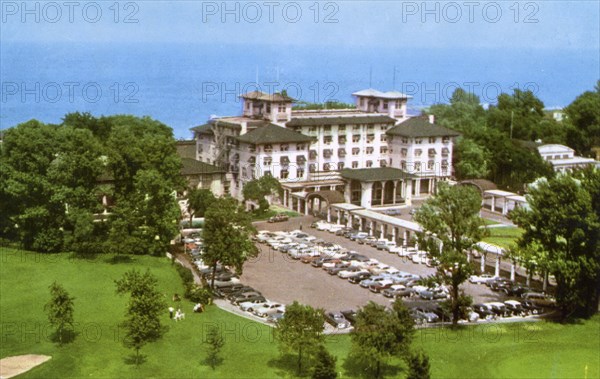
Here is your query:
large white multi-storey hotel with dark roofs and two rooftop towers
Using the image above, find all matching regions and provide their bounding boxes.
[192,89,459,213]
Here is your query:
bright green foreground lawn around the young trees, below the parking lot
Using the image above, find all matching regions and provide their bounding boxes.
[0,249,600,378]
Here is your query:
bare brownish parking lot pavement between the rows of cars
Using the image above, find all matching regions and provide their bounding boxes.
[240,216,503,310]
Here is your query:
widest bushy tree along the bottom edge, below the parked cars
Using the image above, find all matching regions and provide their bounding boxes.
[350,301,414,378]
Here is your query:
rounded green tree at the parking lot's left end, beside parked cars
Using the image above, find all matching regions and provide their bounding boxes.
[202,197,258,287]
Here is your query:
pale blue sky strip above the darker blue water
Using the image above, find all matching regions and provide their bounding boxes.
[0,0,600,49]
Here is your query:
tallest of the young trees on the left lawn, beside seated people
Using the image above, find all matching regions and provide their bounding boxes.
[115,269,166,365]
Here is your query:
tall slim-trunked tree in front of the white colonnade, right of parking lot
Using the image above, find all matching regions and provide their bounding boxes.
[415,182,485,325]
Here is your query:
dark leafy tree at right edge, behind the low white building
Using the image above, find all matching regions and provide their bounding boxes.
[565,80,600,156]
